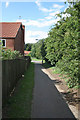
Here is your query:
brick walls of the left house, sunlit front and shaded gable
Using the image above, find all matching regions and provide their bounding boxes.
[2,26,25,55]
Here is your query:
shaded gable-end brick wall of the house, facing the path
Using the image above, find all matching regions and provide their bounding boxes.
[14,27,24,55]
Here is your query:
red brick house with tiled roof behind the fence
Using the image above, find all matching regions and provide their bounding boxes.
[0,22,25,55]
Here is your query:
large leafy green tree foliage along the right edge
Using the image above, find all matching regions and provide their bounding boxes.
[45,2,80,87]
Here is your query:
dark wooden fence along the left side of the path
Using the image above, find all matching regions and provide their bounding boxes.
[2,57,30,106]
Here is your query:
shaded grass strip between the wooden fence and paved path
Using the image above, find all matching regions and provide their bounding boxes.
[2,63,34,118]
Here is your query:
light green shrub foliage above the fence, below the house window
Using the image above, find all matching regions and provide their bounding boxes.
[2,49,22,59]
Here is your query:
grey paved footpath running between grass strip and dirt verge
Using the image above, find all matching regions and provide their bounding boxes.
[32,62,74,118]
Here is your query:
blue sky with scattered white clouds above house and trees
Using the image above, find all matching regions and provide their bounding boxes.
[1,0,68,43]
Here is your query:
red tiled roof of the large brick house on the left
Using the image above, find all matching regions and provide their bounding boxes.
[0,22,22,38]
